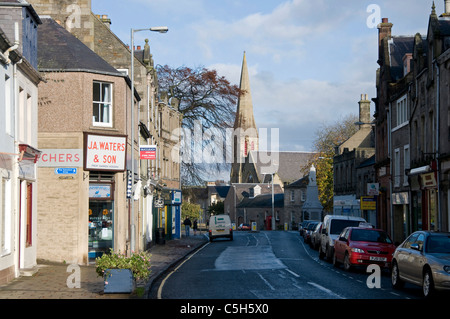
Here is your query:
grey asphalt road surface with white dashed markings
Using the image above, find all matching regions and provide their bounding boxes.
[149,231,426,299]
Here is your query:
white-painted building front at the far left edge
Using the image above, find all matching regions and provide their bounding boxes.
[0,0,42,284]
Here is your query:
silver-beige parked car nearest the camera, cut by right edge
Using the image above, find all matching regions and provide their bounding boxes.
[391,231,450,297]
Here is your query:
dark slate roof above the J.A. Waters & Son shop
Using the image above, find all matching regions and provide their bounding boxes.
[38,17,124,77]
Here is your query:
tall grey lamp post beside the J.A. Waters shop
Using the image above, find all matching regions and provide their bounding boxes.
[130,27,169,251]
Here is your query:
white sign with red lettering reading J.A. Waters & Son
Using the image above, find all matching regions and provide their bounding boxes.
[84,133,127,172]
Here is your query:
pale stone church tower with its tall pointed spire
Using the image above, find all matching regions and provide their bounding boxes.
[230,52,259,183]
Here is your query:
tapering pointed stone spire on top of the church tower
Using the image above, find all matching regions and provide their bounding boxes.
[234,51,256,130]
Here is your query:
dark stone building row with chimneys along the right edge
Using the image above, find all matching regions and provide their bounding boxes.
[374,0,450,242]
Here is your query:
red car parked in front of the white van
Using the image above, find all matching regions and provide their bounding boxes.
[333,227,396,270]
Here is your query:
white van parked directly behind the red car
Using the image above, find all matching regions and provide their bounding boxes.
[319,215,367,260]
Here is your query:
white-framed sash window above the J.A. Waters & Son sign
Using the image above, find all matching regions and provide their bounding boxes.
[92,82,112,127]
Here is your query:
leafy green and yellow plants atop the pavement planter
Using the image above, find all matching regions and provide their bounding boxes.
[95,249,151,281]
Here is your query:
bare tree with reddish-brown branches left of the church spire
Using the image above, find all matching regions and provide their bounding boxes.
[157,65,240,185]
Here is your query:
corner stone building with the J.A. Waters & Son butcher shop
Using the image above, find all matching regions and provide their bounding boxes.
[38,17,134,264]
